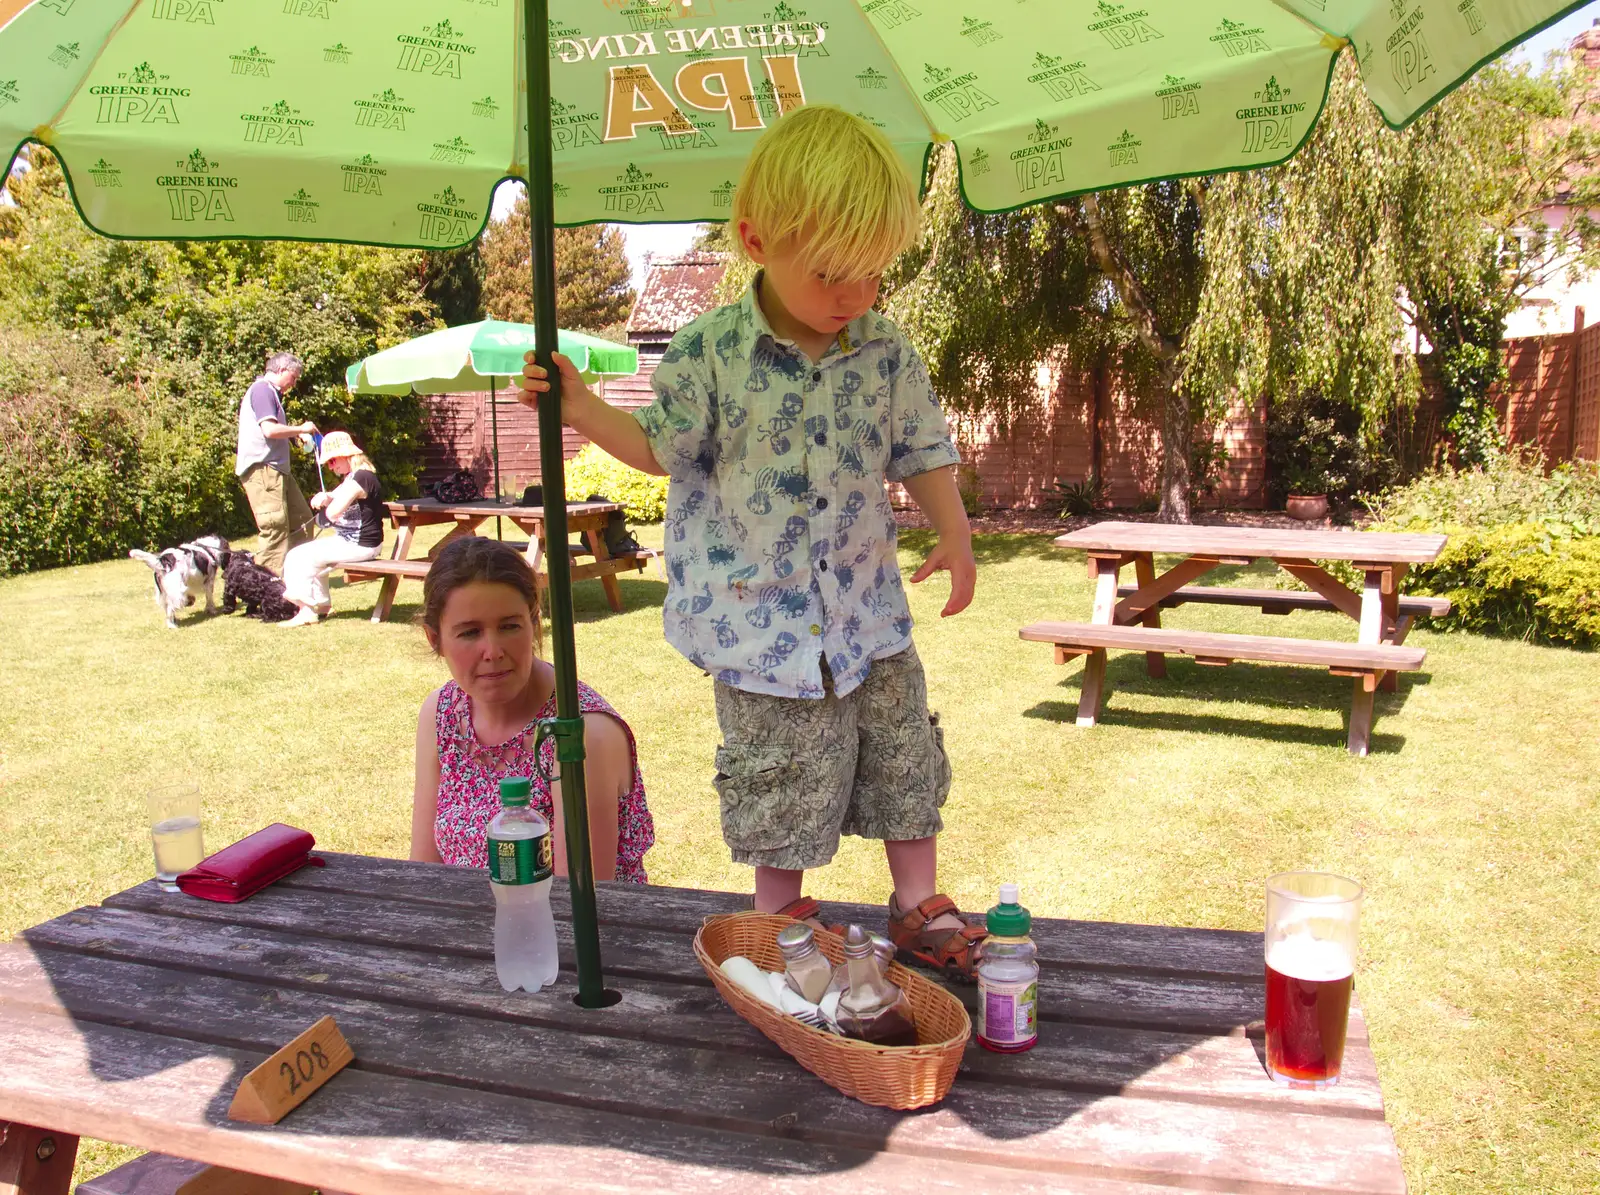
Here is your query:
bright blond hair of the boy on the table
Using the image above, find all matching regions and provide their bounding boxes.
[730,104,922,282]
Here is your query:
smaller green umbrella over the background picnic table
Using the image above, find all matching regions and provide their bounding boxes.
[344,320,638,498]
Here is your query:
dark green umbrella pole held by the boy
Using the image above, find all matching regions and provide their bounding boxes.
[523,0,621,1008]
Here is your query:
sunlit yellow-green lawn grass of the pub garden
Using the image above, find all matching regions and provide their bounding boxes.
[0,528,1600,1193]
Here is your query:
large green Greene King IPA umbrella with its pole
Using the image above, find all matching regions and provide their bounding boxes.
[0,0,1582,1006]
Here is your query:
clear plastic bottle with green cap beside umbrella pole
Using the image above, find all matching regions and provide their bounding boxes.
[488,776,560,992]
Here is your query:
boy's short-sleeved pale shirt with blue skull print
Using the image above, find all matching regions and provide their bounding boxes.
[635,278,960,697]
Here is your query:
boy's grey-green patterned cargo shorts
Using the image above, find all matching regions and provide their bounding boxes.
[715,646,950,870]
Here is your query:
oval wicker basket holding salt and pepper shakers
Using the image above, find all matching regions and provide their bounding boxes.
[694,913,973,1112]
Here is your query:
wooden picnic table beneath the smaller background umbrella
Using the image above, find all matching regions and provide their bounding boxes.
[342,498,654,622]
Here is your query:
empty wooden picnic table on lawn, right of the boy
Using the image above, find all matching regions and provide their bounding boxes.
[1021,523,1450,755]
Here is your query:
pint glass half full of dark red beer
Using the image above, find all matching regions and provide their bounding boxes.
[1267,872,1362,1088]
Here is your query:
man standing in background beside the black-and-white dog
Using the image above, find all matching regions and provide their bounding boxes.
[234,352,317,576]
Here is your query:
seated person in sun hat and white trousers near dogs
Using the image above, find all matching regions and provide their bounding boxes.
[278,432,387,627]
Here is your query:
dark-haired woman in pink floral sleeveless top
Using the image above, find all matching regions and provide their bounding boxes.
[411,536,656,883]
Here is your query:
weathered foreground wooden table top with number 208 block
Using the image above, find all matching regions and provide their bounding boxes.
[0,854,1405,1195]
